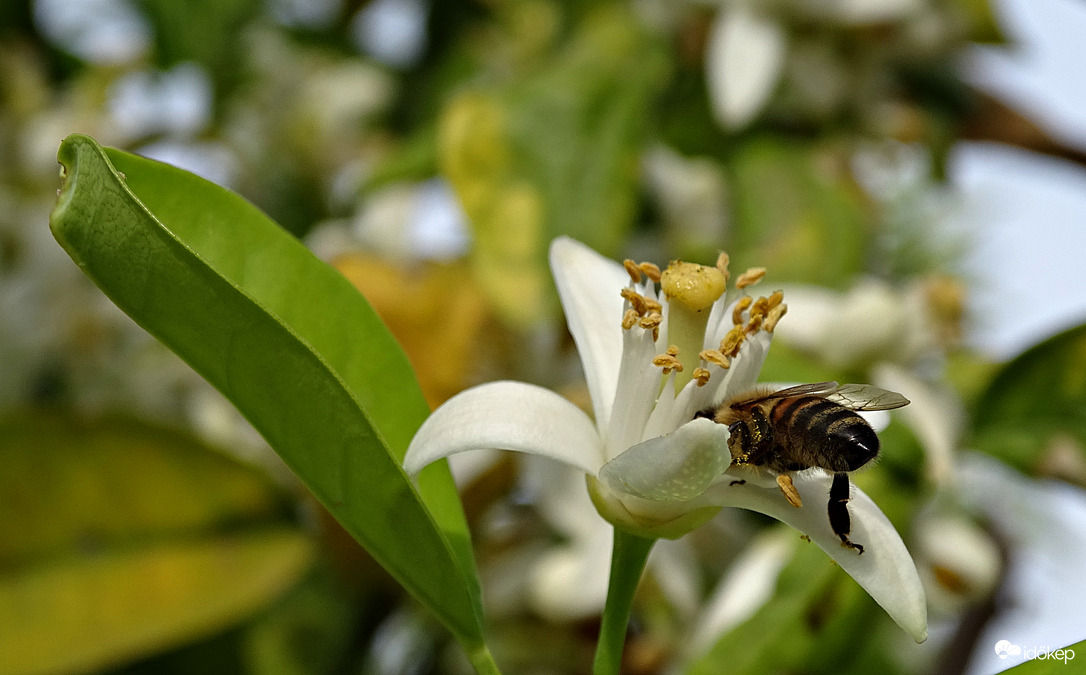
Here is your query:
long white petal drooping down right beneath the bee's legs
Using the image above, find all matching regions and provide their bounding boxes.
[706,472,927,642]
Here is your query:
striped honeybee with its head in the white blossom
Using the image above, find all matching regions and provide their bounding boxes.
[696,382,909,555]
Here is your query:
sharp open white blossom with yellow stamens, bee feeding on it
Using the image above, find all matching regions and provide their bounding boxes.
[404,238,927,641]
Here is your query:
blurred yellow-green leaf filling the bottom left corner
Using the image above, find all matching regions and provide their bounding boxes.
[0,413,314,675]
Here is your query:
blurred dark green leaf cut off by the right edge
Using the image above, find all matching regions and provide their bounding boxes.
[973,326,1086,480]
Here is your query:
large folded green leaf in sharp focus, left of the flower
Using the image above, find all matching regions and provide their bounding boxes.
[51,135,482,651]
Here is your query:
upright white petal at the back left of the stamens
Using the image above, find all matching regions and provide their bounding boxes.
[551,237,630,430]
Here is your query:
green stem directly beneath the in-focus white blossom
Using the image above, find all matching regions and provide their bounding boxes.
[592,528,656,675]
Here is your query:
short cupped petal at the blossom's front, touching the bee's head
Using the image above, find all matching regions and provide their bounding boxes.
[599,419,732,501]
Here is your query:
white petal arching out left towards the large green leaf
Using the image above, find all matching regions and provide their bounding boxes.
[404,382,603,475]
